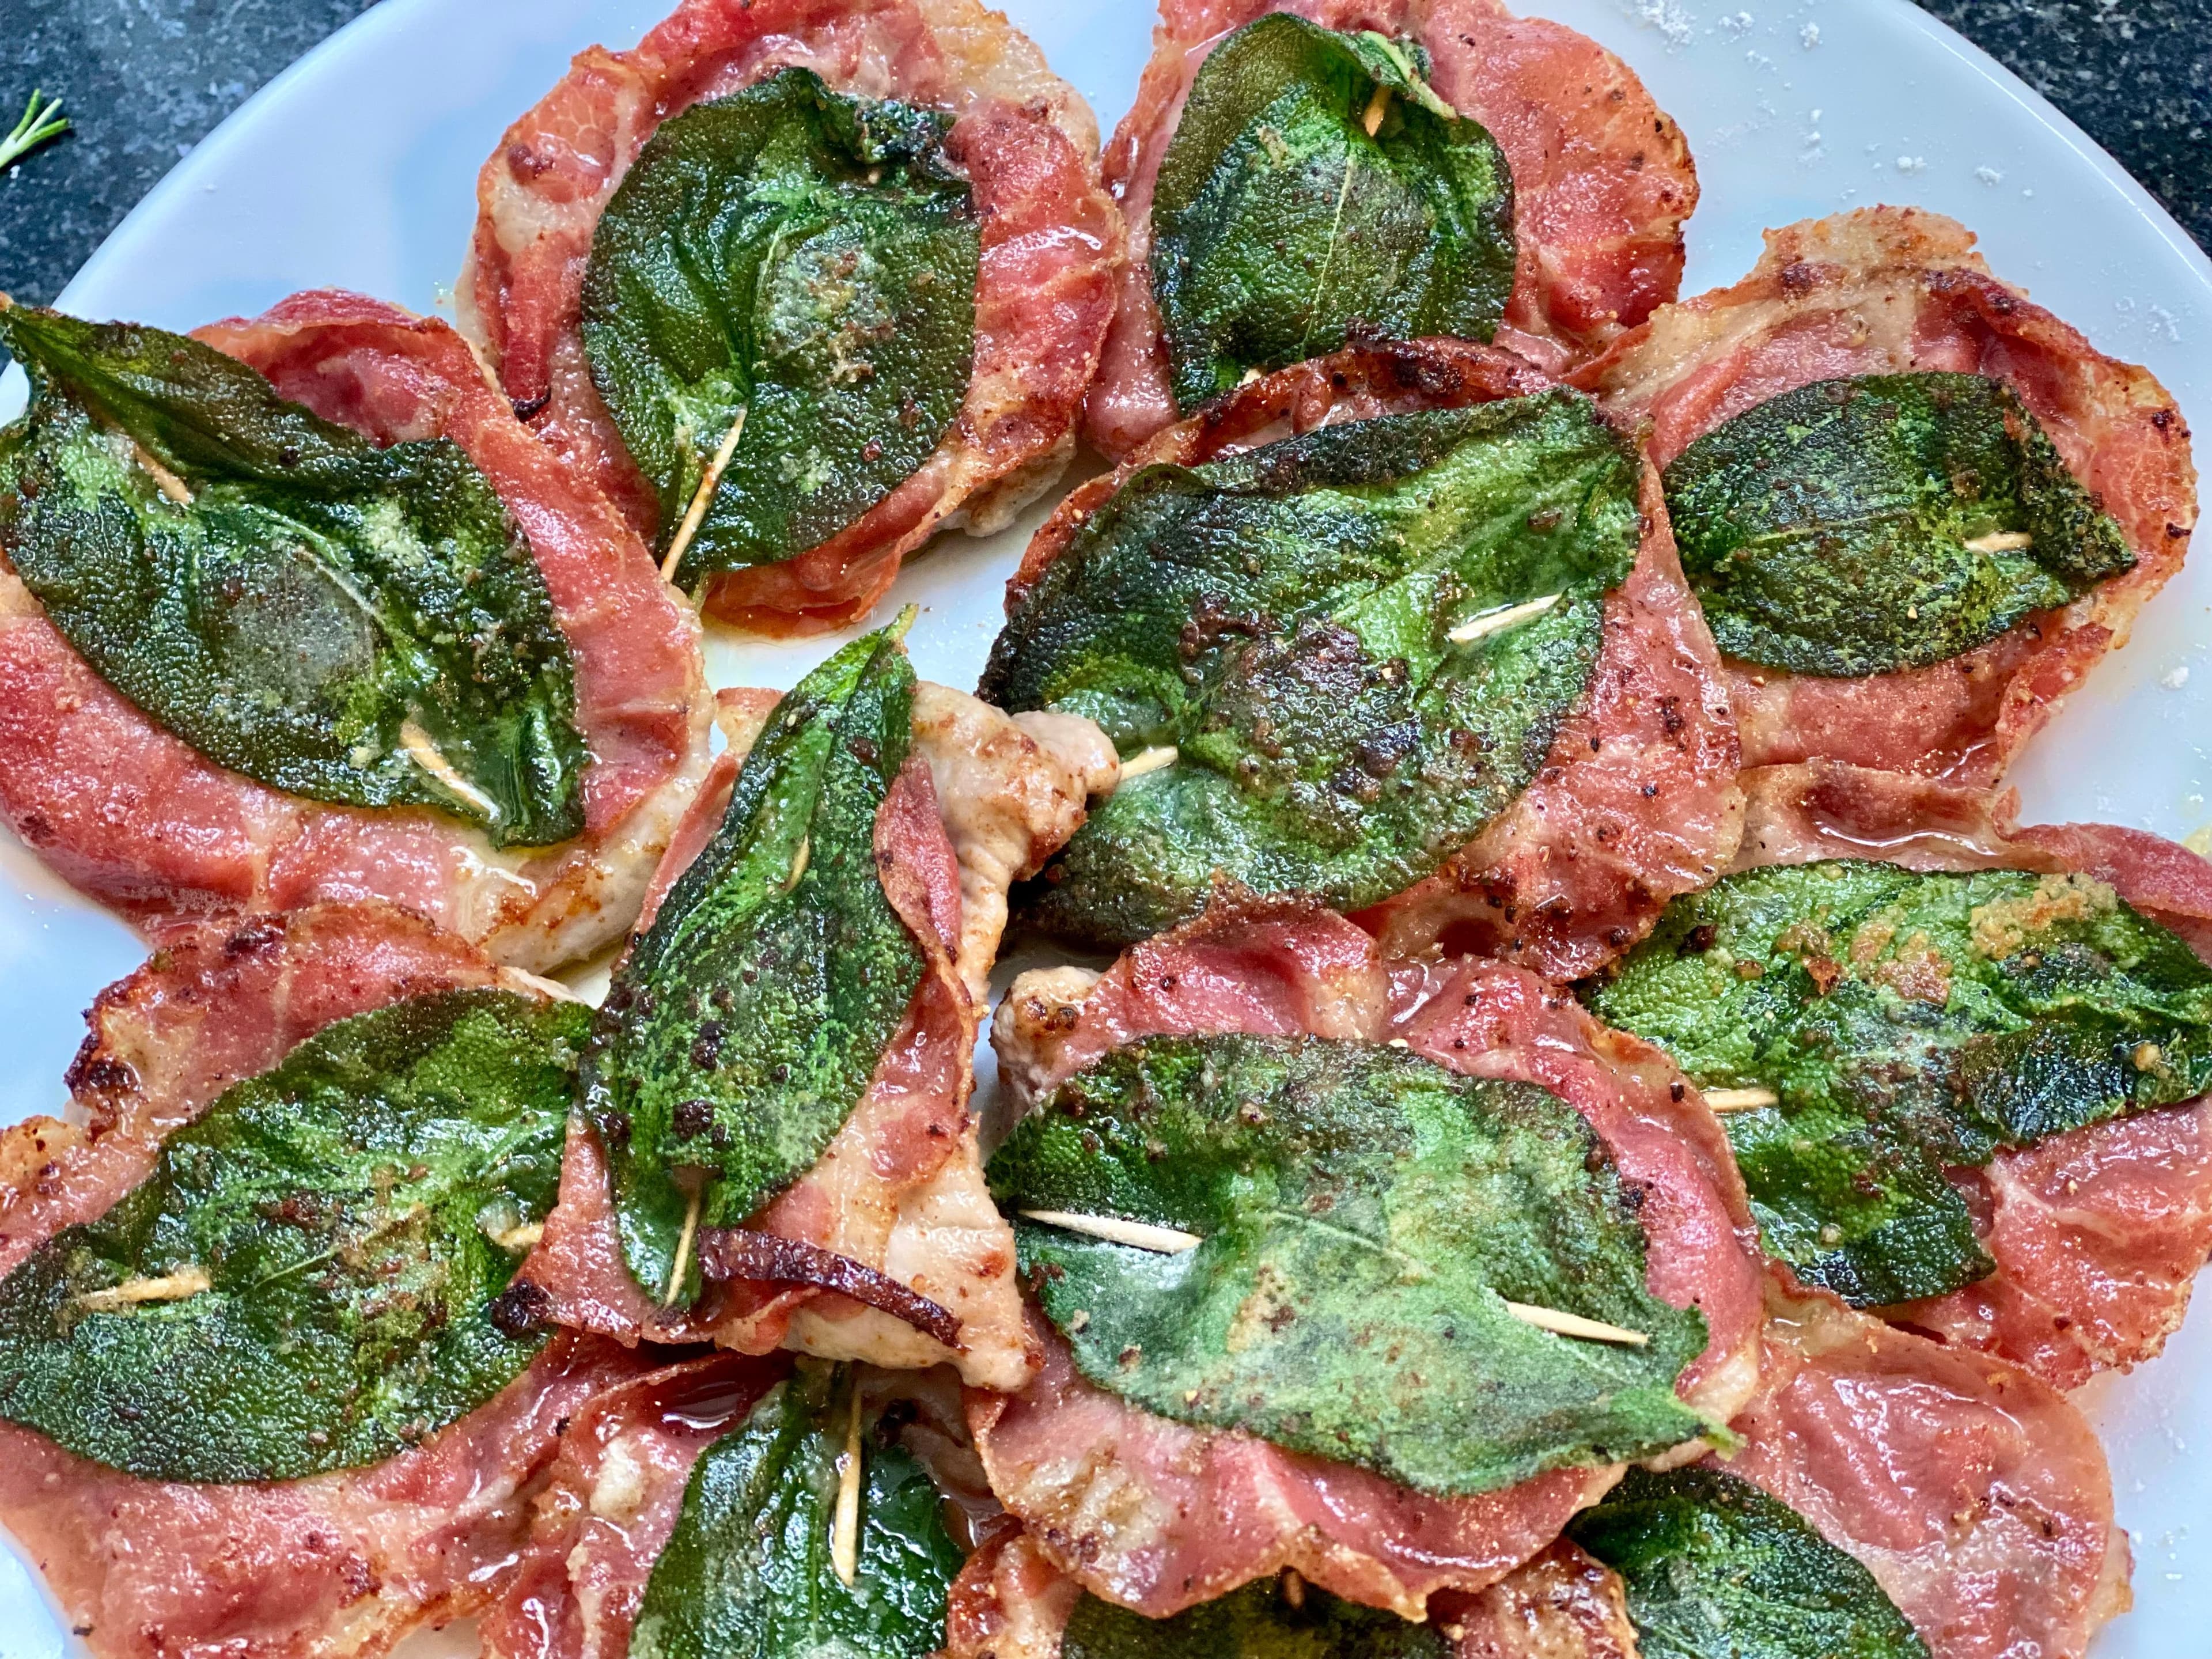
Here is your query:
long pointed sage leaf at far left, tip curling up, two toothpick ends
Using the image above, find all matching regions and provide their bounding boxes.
[0,305,586,847]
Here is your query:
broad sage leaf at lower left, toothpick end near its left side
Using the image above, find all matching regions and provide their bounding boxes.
[0,991,590,1482]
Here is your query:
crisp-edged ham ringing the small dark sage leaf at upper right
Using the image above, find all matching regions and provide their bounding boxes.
[1575,208,2196,783]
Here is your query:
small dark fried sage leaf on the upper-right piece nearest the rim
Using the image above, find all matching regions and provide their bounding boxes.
[1666,374,2135,677]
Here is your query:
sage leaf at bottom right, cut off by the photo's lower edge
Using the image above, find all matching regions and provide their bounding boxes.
[1566,1469,1929,1659]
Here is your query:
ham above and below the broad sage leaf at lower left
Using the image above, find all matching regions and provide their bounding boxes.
[0,905,654,1659]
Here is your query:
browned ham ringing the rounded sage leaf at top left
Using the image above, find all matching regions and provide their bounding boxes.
[458,0,1124,632]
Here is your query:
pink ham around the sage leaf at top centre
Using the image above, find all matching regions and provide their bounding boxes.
[1084,0,1696,458]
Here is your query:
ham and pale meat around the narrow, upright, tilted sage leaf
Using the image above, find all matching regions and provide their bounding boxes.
[522,684,1117,1387]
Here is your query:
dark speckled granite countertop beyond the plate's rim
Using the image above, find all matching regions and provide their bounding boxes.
[0,0,2212,301]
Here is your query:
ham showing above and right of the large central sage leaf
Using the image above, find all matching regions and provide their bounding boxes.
[1006,340,1743,980]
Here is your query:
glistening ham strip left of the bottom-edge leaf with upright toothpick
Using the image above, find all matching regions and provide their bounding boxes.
[478,1354,785,1659]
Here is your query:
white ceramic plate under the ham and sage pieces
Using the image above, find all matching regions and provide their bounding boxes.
[0,0,2212,1659]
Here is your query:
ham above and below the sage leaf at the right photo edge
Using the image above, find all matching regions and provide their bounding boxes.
[1738,766,2212,1389]
